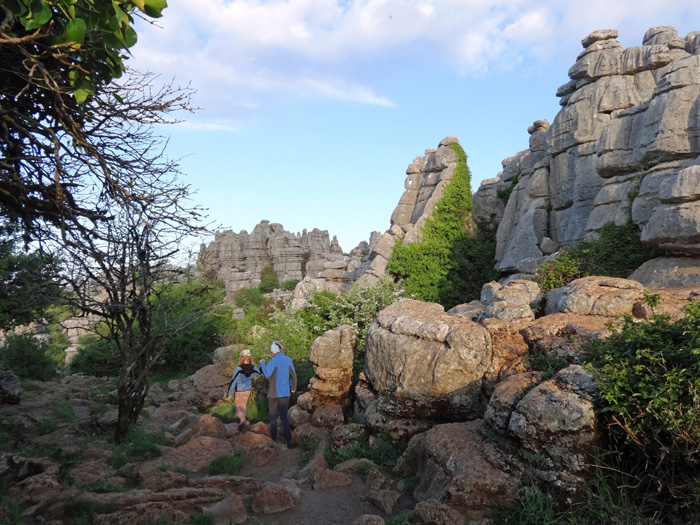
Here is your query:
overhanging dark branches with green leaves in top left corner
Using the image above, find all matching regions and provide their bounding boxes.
[0,0,166,242]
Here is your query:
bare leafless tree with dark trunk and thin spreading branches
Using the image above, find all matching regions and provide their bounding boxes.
[47,74,206,442]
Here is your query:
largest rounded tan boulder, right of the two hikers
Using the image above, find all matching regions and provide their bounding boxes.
[365,299,492,420]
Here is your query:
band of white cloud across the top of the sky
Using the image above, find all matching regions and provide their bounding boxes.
[129,0,700,129]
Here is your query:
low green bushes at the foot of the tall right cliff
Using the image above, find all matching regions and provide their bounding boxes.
[536,222,663,292]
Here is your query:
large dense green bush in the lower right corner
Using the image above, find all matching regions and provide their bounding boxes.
[586,303,700,513]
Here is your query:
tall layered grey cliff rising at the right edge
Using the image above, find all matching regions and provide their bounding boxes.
[474,26,700,271]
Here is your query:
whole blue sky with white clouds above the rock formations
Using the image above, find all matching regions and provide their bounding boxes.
[131,0,700,252]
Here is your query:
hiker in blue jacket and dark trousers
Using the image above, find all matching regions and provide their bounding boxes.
[260,341,297,447]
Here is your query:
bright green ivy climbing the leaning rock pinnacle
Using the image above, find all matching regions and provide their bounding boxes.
[387,144,495,308]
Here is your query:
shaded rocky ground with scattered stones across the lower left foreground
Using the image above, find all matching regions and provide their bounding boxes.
[0,377,415,525]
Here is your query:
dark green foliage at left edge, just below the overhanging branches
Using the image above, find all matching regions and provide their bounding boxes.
[0,223,62,330]
